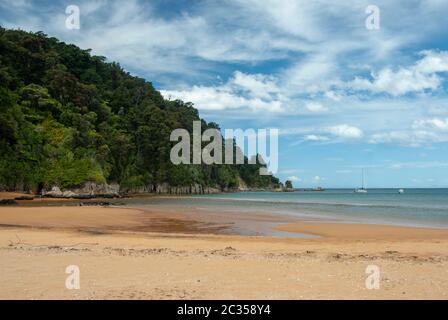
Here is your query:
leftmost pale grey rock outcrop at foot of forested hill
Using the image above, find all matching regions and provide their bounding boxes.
[42,182,120,199]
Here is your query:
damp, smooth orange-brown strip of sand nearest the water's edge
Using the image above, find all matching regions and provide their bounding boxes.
[0,202,448,240]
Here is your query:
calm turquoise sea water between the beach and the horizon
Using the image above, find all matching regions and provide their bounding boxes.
[125,189,448,228]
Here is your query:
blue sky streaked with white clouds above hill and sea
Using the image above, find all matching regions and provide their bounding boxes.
[0,0,448,188]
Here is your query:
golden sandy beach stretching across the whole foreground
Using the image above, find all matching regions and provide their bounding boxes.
[0,200,448,299]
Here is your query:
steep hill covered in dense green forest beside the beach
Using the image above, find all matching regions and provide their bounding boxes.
[0,27,278,192]
